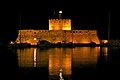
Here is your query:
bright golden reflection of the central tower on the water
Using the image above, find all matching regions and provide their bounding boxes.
[49,48,72,75]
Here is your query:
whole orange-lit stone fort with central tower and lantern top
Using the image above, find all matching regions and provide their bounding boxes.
[16,11,100,45]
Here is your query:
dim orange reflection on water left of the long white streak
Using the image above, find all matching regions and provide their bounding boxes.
[17,48,34,67]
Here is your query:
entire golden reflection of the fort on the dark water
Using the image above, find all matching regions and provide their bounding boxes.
[17,47,111,80]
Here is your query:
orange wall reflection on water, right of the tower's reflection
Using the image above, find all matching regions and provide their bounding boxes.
[73,47,100,67]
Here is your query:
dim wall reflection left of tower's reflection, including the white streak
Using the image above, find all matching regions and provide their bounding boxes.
[17,48,48,67]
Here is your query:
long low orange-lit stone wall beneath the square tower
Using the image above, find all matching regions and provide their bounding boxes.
[16,29,100,45]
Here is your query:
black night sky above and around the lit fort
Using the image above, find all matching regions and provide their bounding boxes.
[0,1,120,43]
